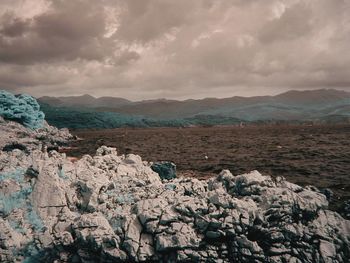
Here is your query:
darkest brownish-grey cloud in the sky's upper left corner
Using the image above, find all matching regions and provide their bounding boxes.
[0,1,113,64]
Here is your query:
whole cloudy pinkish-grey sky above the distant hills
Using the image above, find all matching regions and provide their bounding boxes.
[0,0,350,100]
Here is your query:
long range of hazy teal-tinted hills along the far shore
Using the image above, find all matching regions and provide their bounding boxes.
[39,89,350,128]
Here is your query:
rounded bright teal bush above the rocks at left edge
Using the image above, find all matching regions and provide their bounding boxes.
[0,90,45,129]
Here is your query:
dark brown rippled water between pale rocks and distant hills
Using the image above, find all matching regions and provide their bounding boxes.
[68,125,350,211]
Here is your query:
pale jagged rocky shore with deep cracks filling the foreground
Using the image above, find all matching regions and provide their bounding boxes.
[0,92,350,262]
